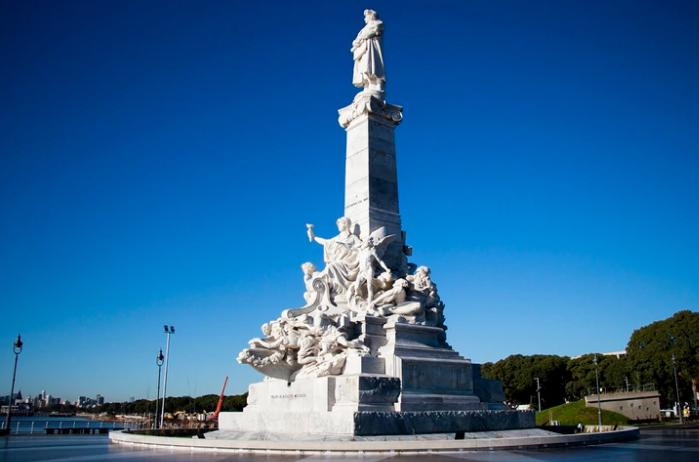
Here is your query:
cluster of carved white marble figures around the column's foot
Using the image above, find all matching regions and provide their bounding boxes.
[238,217,446,380]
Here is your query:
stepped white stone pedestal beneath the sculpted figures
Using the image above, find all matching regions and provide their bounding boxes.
[219,316,534,436]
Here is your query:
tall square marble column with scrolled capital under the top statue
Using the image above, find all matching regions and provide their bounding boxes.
[339,91,409,273]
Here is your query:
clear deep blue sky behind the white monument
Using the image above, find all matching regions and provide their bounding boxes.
[0,0,699,400]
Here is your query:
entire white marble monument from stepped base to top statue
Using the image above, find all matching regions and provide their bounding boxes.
[219,10,534,436]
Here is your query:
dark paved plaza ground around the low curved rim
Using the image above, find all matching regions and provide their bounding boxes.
[0,428,699,462]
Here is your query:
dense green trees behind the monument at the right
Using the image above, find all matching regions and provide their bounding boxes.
[482,310,699,408]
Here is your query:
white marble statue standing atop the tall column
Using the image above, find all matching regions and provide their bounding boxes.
[350,10,386,92]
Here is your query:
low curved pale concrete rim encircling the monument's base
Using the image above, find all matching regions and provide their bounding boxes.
[109,427,639,455]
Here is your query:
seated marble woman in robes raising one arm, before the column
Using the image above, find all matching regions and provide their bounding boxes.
[307,217,362,293]
